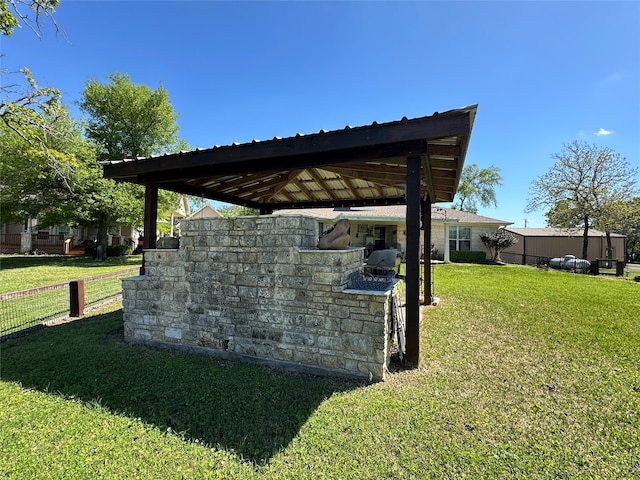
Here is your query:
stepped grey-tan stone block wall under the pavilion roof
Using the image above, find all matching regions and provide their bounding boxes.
[123,215,392,380]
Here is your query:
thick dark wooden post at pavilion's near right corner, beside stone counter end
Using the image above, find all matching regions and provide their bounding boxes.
[405,156,422,368]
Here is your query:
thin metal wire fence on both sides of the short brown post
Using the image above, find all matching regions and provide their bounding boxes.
[0,267,139,340]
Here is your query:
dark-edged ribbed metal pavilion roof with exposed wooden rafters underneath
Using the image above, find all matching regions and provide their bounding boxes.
[103,105,477,212]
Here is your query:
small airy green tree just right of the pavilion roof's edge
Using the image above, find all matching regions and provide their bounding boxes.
[452,163,502,213]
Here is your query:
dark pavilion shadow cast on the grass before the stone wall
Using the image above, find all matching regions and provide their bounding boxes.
[2,310,362,463]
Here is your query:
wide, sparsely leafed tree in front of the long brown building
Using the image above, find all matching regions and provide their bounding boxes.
[527,140,638,258]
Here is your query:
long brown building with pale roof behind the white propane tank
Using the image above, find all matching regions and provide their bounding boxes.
[500,228,626,265]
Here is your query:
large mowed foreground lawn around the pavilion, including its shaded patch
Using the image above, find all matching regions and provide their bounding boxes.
[0,264,640,479]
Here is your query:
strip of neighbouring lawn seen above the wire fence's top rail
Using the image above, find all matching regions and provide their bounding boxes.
[0,255,142,293]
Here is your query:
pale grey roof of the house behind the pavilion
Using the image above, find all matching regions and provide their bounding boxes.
[274,205,511,225]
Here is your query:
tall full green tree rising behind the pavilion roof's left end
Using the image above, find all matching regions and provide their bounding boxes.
[79,73,186,252]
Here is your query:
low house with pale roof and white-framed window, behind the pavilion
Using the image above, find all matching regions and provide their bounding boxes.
[274,205,511,261]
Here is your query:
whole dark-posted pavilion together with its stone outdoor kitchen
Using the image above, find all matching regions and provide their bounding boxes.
[104,106,477,380]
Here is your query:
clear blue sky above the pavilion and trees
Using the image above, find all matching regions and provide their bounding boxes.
[1,0,640,227]
